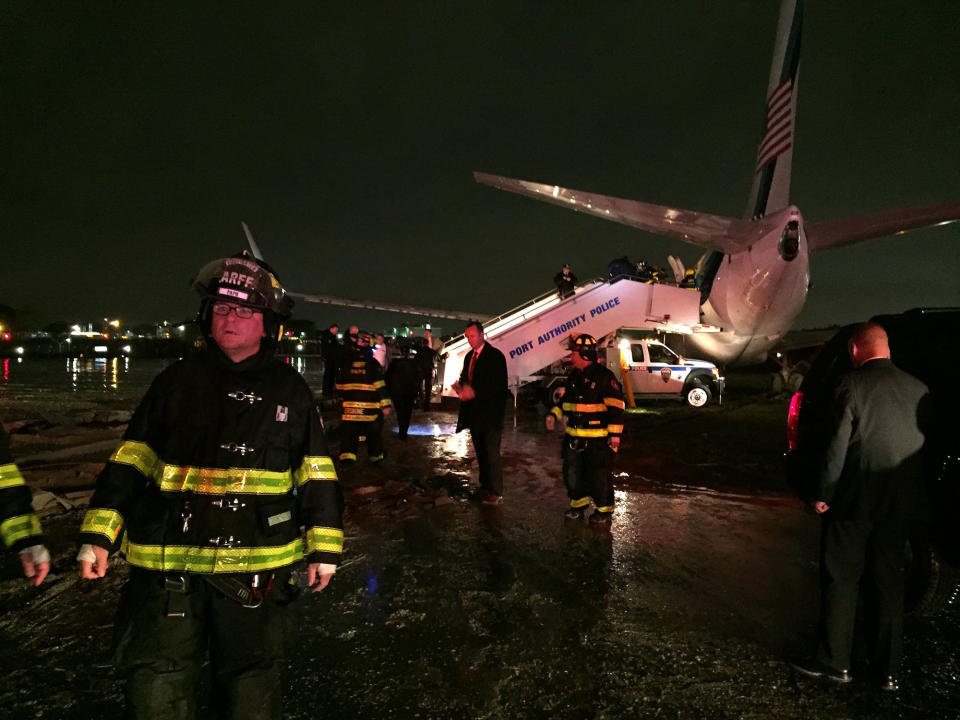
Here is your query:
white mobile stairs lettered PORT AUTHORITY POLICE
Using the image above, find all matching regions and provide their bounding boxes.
[437,276,702,397]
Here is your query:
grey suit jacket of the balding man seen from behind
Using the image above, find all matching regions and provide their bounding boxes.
[819,358,931,522]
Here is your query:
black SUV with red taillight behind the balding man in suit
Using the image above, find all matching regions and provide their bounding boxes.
[786,308,960,612]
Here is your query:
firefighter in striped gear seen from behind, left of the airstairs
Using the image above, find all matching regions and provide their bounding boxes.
[337,333,390,464]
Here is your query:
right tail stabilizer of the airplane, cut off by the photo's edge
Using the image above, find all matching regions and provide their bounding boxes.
[805,202,960,252]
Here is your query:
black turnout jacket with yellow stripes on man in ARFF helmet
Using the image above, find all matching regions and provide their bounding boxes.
[81,346,343,573]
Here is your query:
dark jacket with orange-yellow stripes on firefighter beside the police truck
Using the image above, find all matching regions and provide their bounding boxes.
[551,363,624,439]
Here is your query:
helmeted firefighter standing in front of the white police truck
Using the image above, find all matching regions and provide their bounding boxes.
[546,334,624,524]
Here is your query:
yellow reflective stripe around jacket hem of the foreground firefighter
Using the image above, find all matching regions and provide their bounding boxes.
[123,538,303,573]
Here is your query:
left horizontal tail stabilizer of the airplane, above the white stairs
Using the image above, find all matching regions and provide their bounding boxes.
[473,172,768,253]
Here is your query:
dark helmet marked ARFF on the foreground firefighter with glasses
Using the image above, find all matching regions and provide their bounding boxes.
[193,250,293,320]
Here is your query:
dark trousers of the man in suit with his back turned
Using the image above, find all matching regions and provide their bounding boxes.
[817,520,907,678]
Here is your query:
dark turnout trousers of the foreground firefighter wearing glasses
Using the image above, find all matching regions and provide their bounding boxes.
[114,567,298,720]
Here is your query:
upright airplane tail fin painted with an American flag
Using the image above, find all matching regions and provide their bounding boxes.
[744,0,803,217]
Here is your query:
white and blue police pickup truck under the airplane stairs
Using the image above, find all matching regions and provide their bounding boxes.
[540,335,723,408]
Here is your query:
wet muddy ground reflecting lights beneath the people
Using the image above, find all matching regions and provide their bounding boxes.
[0,375,960,719]
